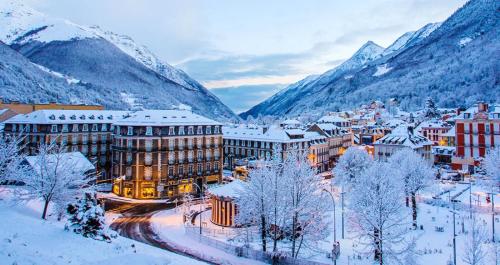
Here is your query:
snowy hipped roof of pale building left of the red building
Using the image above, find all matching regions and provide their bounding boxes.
[375,125,432,149]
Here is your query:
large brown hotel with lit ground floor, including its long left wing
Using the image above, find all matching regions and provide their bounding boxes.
[4,110,222,199]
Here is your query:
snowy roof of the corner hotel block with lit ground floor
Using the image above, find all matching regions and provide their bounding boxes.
[115,110,221,126]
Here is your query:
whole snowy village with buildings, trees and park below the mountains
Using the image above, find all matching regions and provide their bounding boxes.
[1,98,500,264]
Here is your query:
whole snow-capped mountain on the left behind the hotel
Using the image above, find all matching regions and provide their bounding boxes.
[0,0,237,120]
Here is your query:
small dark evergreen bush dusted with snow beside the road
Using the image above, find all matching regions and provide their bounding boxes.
[66,192,111,242]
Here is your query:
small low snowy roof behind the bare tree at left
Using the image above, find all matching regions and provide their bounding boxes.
[25,152,95,173]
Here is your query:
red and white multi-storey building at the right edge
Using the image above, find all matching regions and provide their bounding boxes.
[452,103,500,173]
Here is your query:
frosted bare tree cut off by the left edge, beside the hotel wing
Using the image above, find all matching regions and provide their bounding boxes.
[0,134,25,183]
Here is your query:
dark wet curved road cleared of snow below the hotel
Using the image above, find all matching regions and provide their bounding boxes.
[105,200,216,264]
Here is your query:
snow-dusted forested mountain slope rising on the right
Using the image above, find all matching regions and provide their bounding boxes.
[240,0,500,118]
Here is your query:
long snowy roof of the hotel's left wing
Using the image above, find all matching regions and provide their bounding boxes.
[5,110,128,124]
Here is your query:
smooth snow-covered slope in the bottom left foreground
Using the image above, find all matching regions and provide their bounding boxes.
[0,187,205,265]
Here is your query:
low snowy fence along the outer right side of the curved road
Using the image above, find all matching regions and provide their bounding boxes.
[185,225,327,265]
